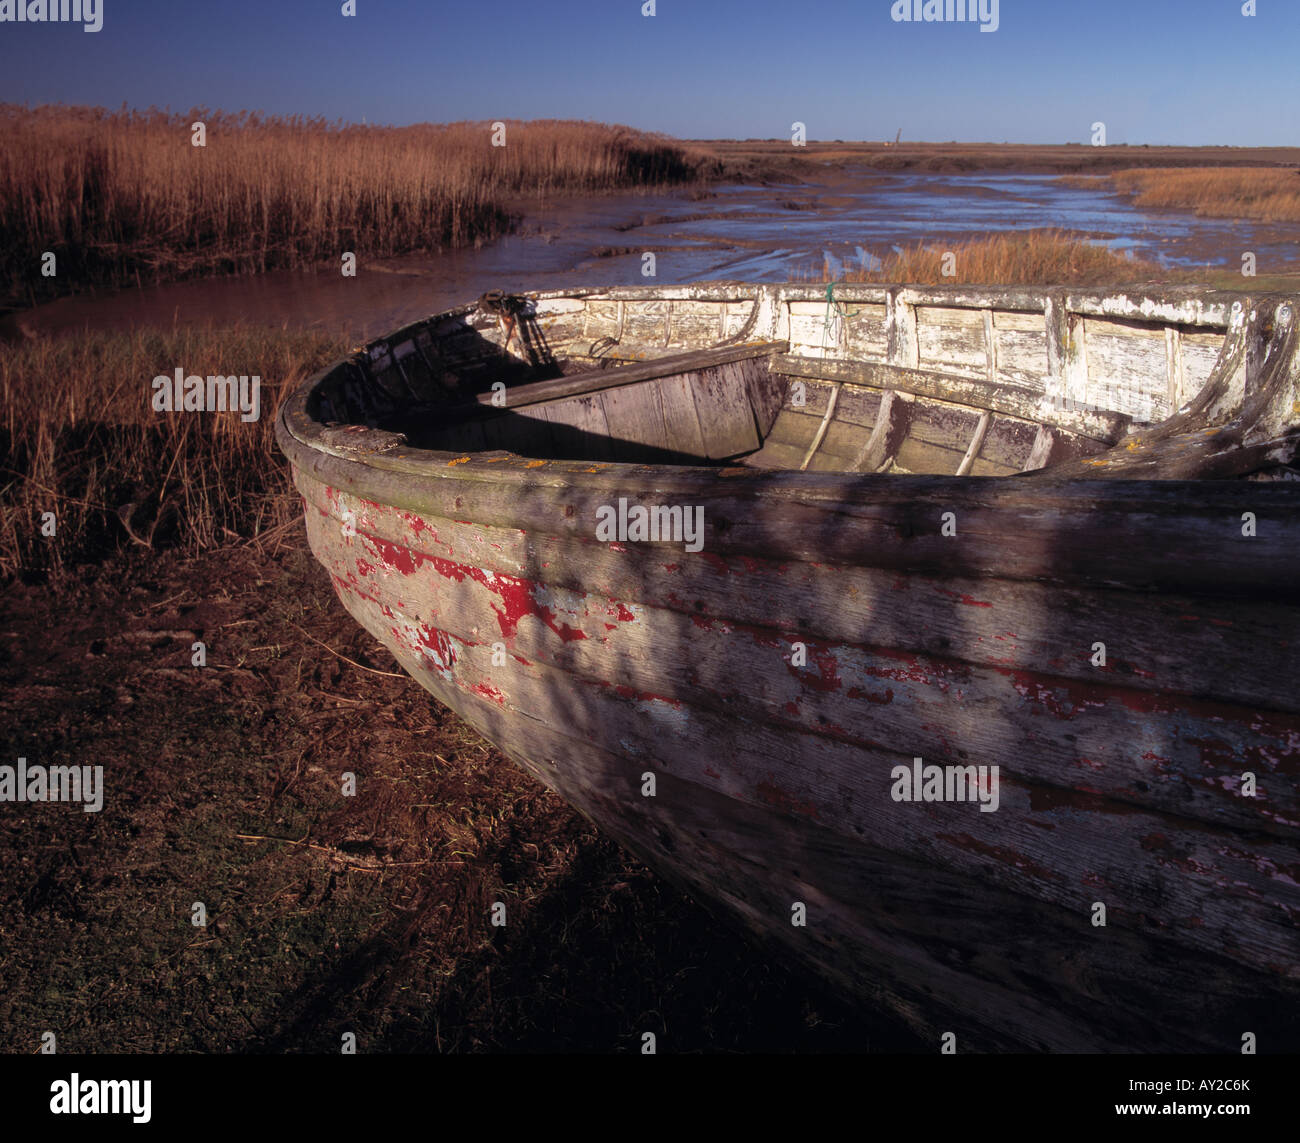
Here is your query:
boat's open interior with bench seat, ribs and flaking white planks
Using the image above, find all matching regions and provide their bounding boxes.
[309,283,1300,480]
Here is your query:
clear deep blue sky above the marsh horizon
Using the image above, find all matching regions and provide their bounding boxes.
[0,0,1300,146]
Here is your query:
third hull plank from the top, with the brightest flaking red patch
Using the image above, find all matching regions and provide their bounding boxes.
[301,483,1300,832]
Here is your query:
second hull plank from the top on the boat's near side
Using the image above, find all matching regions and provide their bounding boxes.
[298,475,1300,717]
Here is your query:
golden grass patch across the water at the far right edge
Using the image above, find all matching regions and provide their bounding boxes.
[1110,166,1300,222]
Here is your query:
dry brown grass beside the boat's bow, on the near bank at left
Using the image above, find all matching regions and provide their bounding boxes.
[0,329,348,580]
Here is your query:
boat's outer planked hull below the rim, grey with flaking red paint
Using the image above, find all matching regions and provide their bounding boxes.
[287,457,1300,1051]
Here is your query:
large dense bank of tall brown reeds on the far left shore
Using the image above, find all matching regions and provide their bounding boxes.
[0,104,705,304]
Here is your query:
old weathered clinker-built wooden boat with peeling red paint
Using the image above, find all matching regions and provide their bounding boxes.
[277,283,1300,1052]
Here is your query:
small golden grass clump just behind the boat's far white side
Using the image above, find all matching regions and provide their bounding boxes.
[822,230,1164,286]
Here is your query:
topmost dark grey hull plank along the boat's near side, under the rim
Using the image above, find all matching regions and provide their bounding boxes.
[280,436,1300,598]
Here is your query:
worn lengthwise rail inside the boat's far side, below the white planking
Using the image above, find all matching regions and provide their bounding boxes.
[772,354,1130,443]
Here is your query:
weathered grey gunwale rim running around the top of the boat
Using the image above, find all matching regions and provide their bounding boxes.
[276,282,1300,594]
